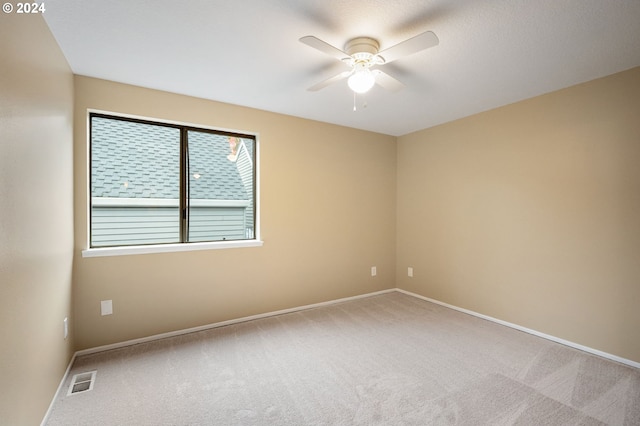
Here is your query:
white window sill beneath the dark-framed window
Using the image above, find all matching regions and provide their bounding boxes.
[82,240,263,257]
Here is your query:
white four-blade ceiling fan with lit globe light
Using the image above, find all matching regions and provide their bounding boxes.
[300,31,439,93]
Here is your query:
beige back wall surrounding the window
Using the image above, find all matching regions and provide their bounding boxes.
[74,76,396,349]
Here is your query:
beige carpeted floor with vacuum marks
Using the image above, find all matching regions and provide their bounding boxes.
[47,292,640,426]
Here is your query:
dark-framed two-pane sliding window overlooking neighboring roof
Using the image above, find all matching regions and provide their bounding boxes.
[90,113,256,248]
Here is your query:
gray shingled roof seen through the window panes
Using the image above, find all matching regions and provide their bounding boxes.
[91,117,253,200]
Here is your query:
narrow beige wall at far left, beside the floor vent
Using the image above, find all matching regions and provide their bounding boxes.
[0,13,73,425]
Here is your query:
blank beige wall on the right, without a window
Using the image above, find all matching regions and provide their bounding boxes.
[396,68,640,362]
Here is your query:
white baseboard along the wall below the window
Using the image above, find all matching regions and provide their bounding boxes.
[76,288,396,356]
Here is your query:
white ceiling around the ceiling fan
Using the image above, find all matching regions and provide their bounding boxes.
[43,0,640,136]
